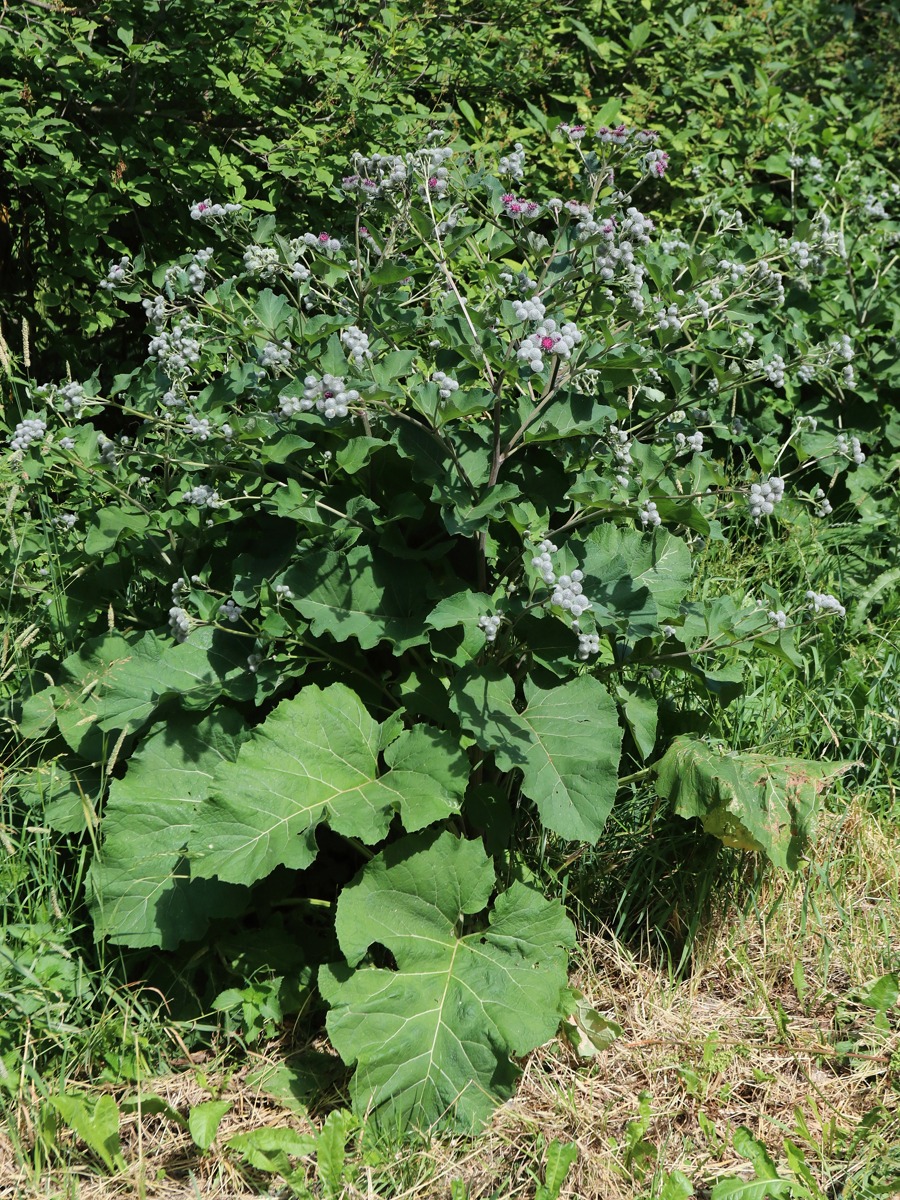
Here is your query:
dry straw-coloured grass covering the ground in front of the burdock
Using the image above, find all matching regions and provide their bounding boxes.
[0,809,900,1200]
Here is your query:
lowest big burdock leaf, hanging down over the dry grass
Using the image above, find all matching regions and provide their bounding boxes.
[319,833,575,1129]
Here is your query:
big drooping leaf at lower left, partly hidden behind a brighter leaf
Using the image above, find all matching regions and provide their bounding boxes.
[90,707,247,949]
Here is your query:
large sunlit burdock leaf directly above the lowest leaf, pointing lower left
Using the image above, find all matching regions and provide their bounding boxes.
[188,684,468,883]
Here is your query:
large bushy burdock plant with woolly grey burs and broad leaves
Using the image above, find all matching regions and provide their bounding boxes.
[8,117,863,1128]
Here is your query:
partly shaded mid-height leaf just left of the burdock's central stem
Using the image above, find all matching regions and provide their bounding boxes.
[284,545,432,654]
